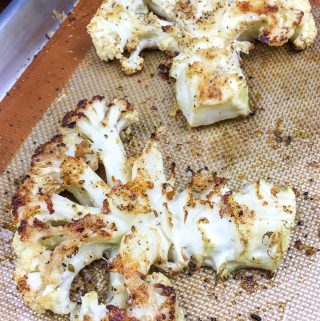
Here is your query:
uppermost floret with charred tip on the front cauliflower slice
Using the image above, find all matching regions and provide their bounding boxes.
[62,96,138,186]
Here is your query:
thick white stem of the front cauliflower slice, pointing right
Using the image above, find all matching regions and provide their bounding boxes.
[167,174,296,276]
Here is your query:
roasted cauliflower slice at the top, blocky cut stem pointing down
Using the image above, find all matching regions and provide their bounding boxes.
[88,0,317,126]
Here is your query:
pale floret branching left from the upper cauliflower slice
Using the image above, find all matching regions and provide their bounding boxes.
[88,0,176,75]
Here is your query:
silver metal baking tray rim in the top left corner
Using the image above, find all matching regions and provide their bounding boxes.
[0,0,76,100]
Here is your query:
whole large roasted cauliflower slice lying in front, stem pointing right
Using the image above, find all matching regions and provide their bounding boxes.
[12,96,296,321]
